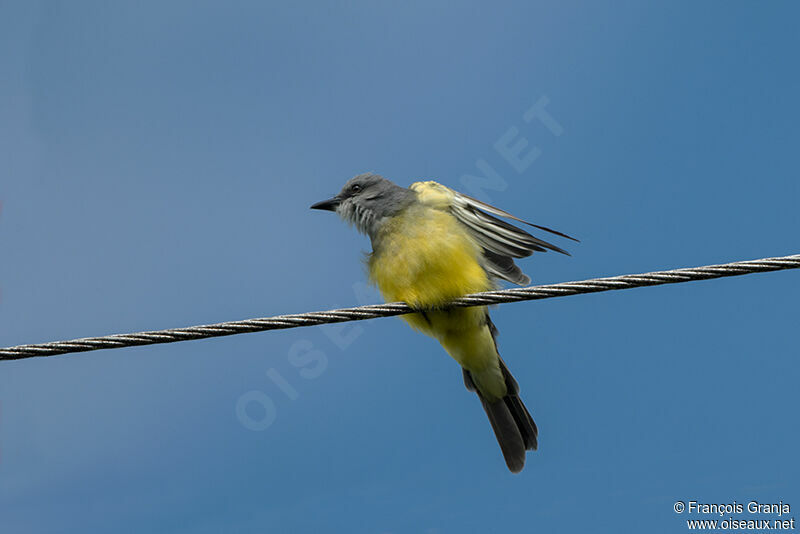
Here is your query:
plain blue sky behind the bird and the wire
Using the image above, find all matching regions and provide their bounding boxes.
[0,1,800,534]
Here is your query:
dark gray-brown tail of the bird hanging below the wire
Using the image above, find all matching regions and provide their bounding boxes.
[463,358,539,473]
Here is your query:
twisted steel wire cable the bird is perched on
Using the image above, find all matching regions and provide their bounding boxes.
[0,254,800,360]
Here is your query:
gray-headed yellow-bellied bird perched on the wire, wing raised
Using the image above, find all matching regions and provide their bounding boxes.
[311,172,578,473]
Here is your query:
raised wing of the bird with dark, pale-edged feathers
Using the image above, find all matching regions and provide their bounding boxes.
[411,182,577,285]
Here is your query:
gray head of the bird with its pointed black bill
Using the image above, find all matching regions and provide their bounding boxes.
[311,172,414,238]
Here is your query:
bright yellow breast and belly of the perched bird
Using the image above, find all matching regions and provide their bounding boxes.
[369,206,505,397]
